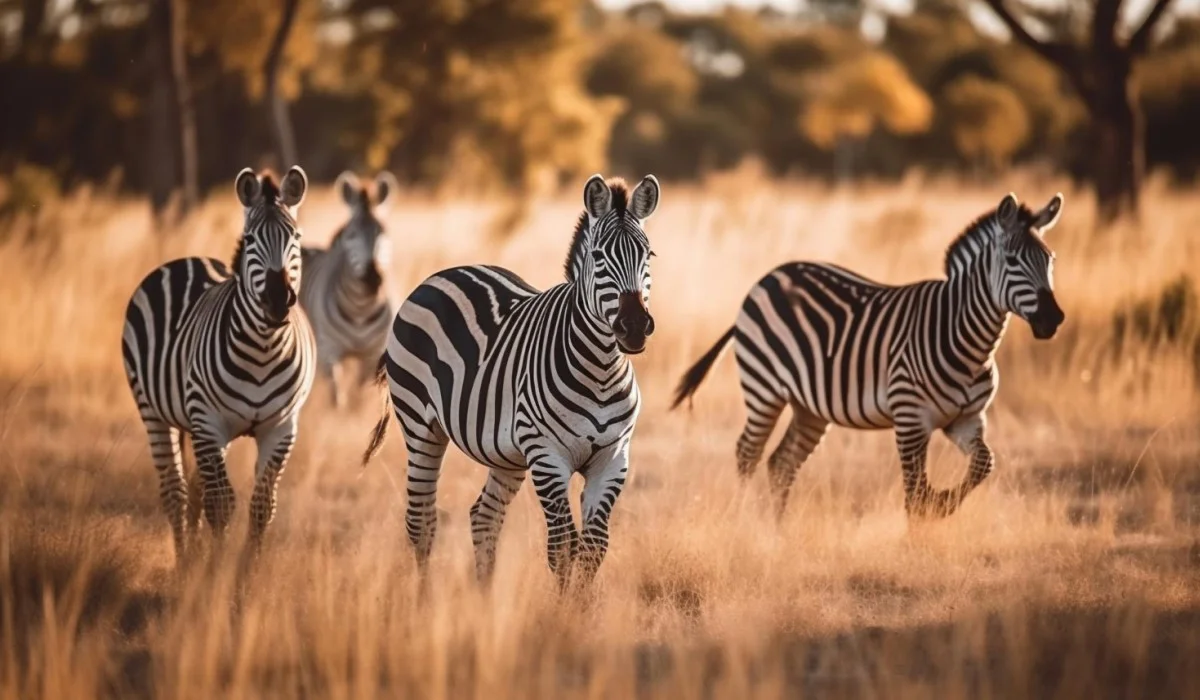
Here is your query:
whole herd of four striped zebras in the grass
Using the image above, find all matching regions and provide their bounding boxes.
[121,167,1064,586]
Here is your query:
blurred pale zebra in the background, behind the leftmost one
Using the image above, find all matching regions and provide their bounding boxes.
[300,172,398,408]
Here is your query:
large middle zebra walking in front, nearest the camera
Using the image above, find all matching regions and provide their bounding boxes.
[362,174,660,587]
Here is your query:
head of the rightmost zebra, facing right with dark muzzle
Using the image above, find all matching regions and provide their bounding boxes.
[996,195,1066,340]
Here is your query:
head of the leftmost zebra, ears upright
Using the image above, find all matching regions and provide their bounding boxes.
[234,166,308,327]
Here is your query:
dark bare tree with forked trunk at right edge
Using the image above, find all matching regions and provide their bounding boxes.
[985,0,1171,221]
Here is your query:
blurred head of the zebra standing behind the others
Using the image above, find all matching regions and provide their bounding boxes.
[334,170,400,294]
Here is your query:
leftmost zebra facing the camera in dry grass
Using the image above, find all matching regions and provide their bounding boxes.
[121,166,317,562]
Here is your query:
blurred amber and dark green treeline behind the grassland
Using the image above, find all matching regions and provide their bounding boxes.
[0,0,1200,203]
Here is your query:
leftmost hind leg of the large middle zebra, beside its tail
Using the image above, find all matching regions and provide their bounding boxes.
[396,411,450,573]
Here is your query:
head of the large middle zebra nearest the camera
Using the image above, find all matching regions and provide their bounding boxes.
[568,175,659,355]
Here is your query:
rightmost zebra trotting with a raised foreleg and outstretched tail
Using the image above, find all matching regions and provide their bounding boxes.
[671,193,1066,517]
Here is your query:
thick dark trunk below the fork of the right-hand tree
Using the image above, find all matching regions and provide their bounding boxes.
[1086,49,1146,223]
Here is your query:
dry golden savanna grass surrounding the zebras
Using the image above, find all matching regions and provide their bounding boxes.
[0,174,1200,700]
